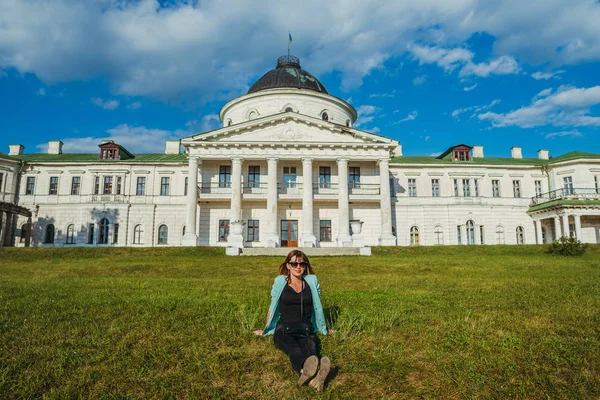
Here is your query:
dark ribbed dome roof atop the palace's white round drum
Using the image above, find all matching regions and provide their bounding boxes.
[248,56,329,94]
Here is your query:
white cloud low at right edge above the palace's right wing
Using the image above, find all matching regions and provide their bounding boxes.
[478,86,600,128]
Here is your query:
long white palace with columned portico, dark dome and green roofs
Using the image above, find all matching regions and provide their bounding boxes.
[0,56,600,249]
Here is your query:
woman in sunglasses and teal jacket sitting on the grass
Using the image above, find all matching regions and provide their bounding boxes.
[254,250,331,391]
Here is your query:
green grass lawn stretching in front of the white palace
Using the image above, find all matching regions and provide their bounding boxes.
[0,246,600,399]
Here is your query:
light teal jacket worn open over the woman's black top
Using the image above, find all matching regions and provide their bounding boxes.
[263,275,327,336]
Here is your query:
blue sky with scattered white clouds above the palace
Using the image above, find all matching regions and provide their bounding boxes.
[0,0,600,157]
